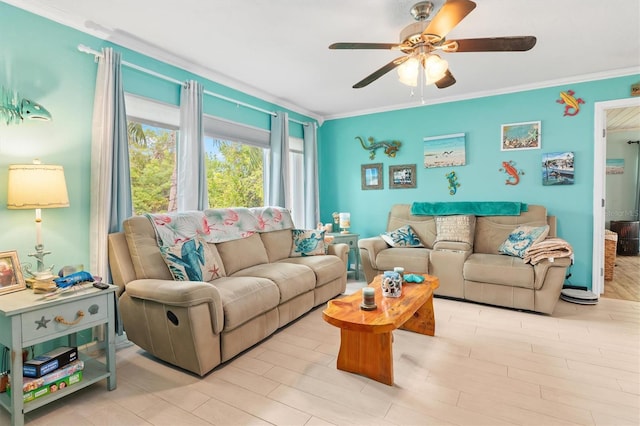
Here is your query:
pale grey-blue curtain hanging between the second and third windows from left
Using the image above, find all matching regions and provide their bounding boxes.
[265,112,291,209]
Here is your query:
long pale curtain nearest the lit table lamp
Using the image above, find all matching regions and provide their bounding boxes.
[89,48,133,282]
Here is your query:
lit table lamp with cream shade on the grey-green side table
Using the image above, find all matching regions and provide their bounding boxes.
[7,160,69,278]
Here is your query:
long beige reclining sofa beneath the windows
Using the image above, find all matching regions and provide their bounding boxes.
[109,209,349,375]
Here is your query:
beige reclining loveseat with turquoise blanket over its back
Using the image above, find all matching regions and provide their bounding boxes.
[358,204,571,314]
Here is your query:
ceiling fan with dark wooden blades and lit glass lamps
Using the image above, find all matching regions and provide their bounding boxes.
[329,0,536,89]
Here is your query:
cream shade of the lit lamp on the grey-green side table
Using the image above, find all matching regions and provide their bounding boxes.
[7,164,69,209]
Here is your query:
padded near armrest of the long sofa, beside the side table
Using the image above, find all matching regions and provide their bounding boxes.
[126,279,224,334]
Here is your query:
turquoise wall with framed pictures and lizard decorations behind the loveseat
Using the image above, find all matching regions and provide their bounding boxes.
[318,75,640,286]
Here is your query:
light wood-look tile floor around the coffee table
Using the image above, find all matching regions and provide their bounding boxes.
[0,292,640,426]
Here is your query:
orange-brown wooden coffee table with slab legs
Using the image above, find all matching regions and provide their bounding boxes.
[322,275,440,386]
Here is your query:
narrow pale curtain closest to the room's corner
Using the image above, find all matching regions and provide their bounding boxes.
[302,123,320,229]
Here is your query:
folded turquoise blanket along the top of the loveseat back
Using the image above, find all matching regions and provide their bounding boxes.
[411,201,528,216]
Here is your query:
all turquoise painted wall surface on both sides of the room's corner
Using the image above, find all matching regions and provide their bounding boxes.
[0,2,639,285]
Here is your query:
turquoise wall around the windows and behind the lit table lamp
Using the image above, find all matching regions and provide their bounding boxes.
[0,2,312,268]
